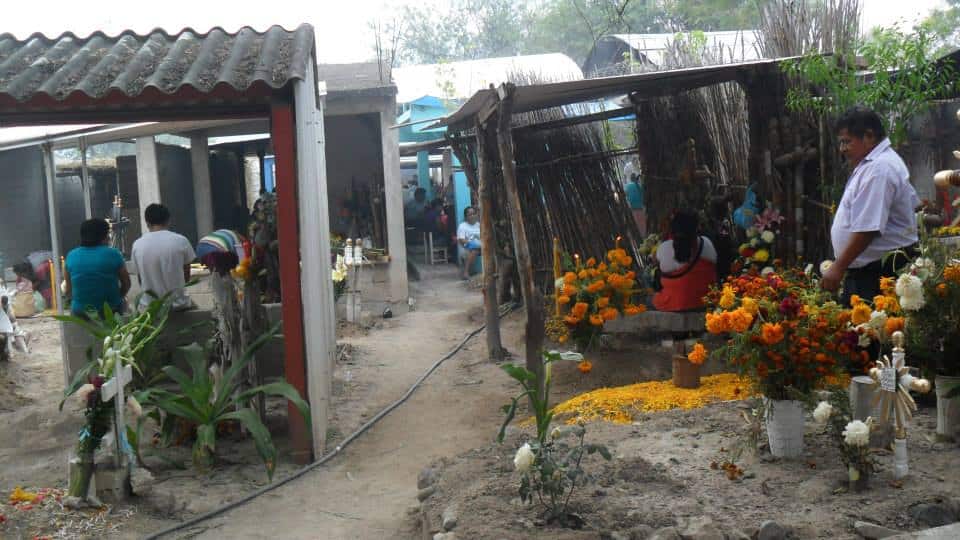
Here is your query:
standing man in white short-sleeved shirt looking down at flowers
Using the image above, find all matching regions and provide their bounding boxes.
[821,107,920,304]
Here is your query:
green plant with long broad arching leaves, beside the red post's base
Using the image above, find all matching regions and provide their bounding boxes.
[144,323,311,479]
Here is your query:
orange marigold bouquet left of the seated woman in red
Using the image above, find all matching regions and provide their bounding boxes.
[555,239,646,352]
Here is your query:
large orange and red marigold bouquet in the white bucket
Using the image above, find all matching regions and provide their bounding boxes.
[706,270,852,400]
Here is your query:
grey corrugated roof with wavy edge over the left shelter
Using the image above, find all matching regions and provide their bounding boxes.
[0,24,314,110]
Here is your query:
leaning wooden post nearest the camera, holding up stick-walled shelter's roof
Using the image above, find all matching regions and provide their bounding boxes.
[497,83,545,388]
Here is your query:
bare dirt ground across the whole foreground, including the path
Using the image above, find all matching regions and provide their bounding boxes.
[0,267,960,539]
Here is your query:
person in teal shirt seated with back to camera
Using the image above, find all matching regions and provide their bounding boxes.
[64,218,130,317]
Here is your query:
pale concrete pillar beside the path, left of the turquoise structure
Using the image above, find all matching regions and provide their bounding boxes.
[380,97,410,302]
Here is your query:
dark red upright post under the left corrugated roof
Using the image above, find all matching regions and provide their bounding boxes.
[270,103,313,461]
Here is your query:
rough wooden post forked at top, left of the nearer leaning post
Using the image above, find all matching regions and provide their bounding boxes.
[466,121,505,362]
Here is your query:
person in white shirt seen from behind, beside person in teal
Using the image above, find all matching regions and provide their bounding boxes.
[131,204,196,311]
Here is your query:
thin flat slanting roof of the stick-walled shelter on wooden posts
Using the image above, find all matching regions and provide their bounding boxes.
[436,58,790,128]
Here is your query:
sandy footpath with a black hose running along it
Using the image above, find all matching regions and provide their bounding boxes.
[191,270,516,539]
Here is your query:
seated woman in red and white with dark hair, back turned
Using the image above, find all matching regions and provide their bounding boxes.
[653,210,717,311]
